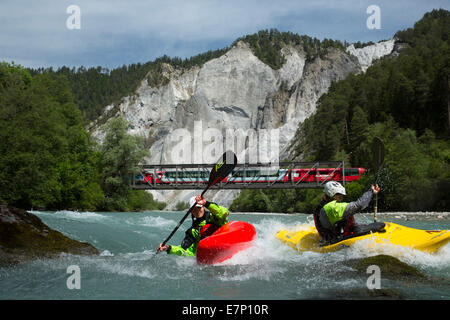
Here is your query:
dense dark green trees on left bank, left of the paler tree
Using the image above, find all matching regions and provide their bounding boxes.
[0,63,102,209]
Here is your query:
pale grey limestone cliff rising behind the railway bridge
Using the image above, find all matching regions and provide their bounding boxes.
[93,40,394,209]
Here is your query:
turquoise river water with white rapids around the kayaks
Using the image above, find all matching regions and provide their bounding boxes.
[0,211,450,300]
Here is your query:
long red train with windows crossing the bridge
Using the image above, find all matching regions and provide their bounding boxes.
[136,168,366,184]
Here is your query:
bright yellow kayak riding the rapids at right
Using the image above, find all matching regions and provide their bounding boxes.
[275,222,450,253]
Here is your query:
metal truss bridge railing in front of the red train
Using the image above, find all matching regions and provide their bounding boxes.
[131,161,345,190]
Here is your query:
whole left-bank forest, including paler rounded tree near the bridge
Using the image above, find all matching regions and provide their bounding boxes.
[0,62,165,211]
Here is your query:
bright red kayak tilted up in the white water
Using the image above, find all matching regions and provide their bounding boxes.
[197,221,256,264]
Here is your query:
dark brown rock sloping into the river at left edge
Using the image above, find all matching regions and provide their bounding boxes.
[0,205,98,266]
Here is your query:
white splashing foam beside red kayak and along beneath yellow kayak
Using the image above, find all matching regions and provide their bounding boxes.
[215,218,450,281]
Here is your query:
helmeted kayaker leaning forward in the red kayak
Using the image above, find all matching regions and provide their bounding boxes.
[157,195,229,256]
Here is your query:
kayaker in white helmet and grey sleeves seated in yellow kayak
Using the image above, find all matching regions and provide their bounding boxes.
[314,181,385,245]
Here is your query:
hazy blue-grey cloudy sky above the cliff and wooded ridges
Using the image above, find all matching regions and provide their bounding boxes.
[0,0,450,69]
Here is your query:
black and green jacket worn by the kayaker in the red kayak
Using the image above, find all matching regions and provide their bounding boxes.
[167,201,229,256]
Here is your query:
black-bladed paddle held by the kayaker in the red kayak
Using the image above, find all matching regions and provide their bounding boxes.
[156,151,237,253]
